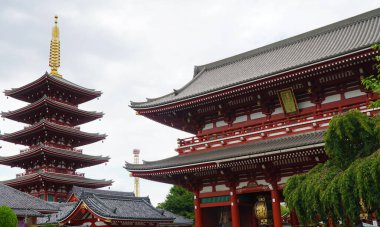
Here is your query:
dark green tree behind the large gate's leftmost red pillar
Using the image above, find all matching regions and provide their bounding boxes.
[157,185,194,219]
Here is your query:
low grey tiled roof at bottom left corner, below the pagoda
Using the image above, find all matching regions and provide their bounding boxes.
[0,183,59,217]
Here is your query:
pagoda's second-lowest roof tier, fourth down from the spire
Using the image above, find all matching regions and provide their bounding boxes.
[0,144,110,166]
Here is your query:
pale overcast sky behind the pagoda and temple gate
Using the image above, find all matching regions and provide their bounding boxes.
[0,0,380,204]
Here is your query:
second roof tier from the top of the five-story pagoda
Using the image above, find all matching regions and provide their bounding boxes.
[1,95,103,126]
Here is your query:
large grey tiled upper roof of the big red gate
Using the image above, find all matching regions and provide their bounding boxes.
[131,8,380,110]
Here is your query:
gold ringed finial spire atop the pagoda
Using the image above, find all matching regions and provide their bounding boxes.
[49,16,62,77]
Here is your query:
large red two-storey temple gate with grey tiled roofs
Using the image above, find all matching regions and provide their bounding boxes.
[125,9,380,227]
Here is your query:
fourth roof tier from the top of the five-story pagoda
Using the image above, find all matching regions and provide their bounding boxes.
[0,145,110,169]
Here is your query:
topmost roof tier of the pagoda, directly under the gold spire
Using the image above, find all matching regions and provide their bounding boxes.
[4,72,102,105]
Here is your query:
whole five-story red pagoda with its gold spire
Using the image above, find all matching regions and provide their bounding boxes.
[0,16,112,201]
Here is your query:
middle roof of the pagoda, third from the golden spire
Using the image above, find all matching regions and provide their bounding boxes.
[0,119,106,147]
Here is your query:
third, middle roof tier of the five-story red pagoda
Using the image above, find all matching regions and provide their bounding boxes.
[0,119,107,147]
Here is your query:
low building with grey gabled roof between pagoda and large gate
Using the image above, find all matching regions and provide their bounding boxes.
[38,186,193,227]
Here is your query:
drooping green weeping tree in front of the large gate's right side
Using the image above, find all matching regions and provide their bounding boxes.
[284,110,380,224]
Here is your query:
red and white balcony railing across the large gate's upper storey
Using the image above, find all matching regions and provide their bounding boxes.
[176,103,380,154]
